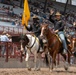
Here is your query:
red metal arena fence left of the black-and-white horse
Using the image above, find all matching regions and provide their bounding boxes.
[0,42,22,62]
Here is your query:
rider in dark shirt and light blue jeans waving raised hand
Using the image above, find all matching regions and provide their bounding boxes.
[49,10,67,54]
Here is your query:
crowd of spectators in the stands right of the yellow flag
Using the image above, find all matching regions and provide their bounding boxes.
[30,1,76,35]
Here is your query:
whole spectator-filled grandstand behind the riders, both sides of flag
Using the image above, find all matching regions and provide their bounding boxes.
[0,0,76,42]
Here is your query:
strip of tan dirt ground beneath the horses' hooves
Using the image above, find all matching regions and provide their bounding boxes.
[0,67,76,75]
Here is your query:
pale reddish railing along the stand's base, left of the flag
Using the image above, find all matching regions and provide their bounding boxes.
[0,26,25,35]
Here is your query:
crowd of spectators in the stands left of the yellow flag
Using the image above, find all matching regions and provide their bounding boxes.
[0,5,22,26]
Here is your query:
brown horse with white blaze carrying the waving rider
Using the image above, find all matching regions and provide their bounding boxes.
[40,24,70,70]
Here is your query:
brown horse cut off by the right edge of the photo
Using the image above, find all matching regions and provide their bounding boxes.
[67,34,76,64]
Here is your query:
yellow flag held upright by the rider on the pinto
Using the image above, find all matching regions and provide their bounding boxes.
[22,0,30,26]
